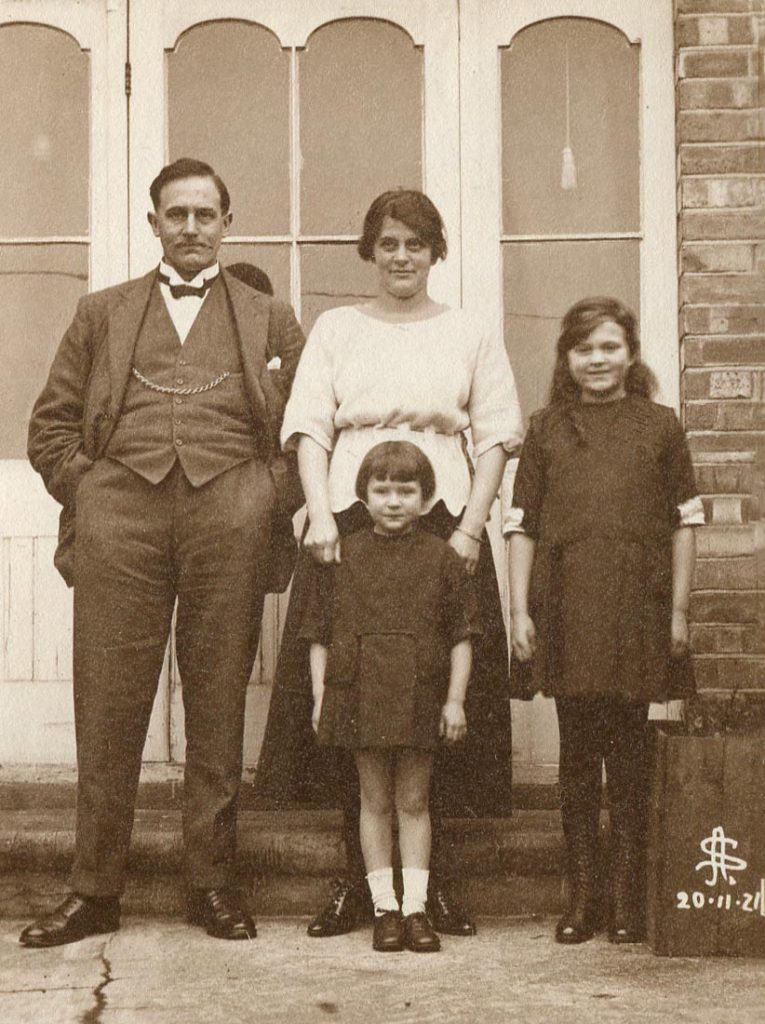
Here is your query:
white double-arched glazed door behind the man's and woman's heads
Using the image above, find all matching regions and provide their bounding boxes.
[130,0,461,764]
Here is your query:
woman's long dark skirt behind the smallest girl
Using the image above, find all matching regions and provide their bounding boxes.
[255,502,512,817]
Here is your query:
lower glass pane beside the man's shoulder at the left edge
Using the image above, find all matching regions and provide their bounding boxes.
[0,245,88,459]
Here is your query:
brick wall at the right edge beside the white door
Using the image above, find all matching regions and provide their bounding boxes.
[675,0,765,691]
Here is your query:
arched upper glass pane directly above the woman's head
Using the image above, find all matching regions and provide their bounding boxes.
[299,18,422,234]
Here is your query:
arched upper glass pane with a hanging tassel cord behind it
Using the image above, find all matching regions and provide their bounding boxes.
[501,17,640,234]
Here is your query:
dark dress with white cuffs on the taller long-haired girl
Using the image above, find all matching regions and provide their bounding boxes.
[511,395,700,701]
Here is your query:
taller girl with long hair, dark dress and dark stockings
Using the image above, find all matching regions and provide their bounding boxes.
[504,298,704,943]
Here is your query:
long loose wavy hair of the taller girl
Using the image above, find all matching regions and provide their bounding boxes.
[549,296,658,406]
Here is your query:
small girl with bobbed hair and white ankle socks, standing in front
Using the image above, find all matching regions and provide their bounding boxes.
[301,441,479,952]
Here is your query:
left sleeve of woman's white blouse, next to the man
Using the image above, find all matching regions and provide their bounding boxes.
[282,313,337,452]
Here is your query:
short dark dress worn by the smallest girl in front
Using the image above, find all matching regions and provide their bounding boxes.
[300,529,480,750]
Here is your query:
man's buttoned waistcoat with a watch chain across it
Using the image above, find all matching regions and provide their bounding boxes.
[105,281,257,486]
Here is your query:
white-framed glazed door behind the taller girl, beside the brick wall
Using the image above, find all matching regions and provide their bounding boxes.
[460,0,679,780]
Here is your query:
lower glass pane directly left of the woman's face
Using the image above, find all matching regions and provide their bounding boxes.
[300,245,377,334]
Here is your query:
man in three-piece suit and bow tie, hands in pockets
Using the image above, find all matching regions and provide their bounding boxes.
[20,159,303,947]
